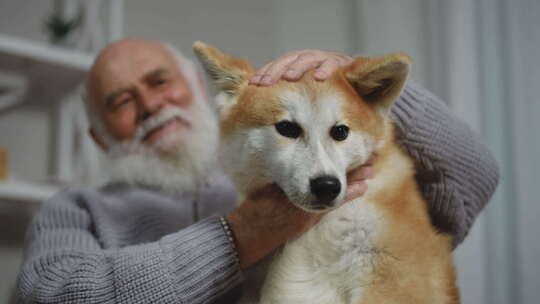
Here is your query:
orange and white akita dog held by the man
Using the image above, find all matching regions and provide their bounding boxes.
[194,42,459,304]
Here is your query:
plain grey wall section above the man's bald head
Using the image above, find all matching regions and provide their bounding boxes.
[124,0,275,66]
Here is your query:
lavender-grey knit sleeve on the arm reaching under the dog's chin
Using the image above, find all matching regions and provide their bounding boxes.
[18,191,241,303]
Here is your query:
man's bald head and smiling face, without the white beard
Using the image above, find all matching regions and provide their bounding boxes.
[87,39,194,152]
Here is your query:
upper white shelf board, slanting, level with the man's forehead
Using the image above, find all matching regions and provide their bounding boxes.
[0,34,94,71]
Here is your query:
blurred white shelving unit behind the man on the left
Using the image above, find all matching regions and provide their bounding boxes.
[0,0,124,202]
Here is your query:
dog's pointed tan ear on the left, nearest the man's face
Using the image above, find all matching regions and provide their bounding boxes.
[193,41,255,96]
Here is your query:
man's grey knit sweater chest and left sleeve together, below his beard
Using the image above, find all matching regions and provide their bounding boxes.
[18,176,242,303]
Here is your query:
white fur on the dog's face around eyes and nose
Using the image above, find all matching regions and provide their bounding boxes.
[221,89,375,211]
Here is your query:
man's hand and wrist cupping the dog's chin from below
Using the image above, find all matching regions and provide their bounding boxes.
[226,162,373,269]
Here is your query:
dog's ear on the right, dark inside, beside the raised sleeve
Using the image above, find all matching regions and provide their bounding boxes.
[345,53,411,115]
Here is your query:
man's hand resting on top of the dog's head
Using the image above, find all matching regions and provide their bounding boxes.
[250,50,353,86]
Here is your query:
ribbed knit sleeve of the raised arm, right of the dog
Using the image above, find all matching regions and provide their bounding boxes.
[392,83,499,247]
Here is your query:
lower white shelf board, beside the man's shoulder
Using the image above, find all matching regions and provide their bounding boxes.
[0,179,63,203]
